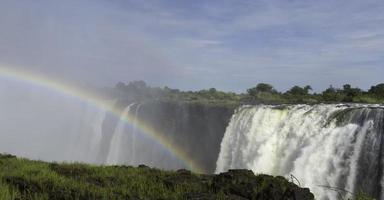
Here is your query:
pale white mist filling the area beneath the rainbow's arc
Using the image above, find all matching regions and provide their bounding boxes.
[0,79,187,169]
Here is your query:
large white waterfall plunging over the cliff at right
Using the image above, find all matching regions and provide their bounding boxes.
[216,105,384,199]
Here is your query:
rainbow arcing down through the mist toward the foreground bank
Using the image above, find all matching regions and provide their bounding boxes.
[0,65,207,173]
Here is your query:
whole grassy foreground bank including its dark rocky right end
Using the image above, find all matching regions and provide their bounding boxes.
[0,154,313,200]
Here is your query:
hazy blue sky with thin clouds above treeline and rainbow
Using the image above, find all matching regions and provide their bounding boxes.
[0,0,384,92]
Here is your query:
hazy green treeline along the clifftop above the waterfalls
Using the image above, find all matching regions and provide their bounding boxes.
[114,81,384,106]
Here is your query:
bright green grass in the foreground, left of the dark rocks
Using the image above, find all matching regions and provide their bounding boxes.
[0,158,192,199]
